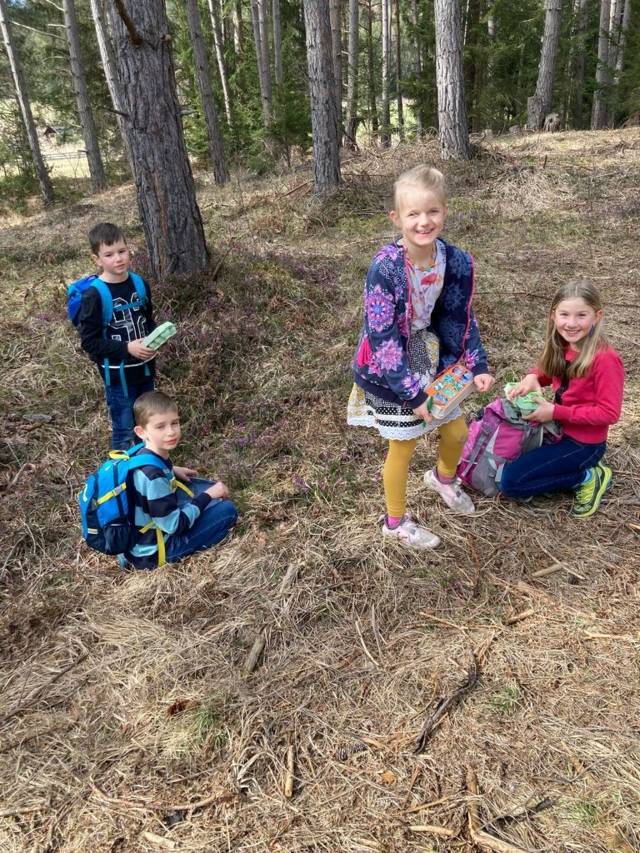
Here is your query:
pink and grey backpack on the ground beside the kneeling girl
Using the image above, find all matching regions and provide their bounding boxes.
[457,397,560,497]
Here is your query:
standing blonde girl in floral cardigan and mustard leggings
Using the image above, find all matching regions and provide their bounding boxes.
[347,166,493,548]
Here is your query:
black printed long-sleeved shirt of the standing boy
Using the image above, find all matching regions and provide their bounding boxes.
[79,276,155,385]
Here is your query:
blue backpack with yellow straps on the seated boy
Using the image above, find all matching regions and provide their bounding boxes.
[78,444,173,566]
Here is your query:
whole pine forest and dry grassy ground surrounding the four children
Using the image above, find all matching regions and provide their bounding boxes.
[0,0,640,853]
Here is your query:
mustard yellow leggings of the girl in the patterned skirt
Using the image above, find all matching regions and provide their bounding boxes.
[382,417,467,518]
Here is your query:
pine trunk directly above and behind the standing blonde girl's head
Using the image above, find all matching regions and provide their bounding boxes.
[434,0,471,160]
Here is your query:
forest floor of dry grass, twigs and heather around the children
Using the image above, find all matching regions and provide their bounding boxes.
[0,129,640,853]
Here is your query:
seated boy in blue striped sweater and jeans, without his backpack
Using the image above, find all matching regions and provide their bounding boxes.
[125,391,238,569]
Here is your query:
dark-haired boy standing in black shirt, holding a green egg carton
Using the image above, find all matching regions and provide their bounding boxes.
[78,222,156,450]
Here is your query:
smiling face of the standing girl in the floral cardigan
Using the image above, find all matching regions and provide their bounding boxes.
[389,186,447,261]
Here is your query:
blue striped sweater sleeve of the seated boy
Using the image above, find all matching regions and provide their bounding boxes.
[133,465,211,536]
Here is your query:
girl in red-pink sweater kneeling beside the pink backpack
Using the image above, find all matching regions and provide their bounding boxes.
[500,281,624,518]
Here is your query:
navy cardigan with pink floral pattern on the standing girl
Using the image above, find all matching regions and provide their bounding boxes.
[353,236,489,409]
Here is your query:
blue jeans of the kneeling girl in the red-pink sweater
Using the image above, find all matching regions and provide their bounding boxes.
[500,437,607,498]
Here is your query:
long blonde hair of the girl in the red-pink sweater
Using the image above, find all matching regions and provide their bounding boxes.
[539,279,608,379]
